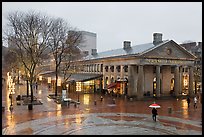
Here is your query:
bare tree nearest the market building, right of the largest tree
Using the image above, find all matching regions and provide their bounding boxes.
[48,18,81,96]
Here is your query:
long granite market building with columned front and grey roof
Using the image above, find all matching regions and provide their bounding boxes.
[38,33,196,99]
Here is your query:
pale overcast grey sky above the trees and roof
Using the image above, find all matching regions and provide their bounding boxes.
[2,2,202,52]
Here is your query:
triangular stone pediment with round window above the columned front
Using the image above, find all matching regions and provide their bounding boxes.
[141,40,195,60]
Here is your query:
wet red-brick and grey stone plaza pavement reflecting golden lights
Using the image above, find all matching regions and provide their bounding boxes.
[2,82,202,135]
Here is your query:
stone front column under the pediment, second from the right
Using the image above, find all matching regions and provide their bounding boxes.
[174,66,181,97]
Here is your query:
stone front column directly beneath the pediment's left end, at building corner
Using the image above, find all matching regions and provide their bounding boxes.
[137,65,144,99]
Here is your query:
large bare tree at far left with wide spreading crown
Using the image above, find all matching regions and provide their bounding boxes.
[6,11,51,109]
